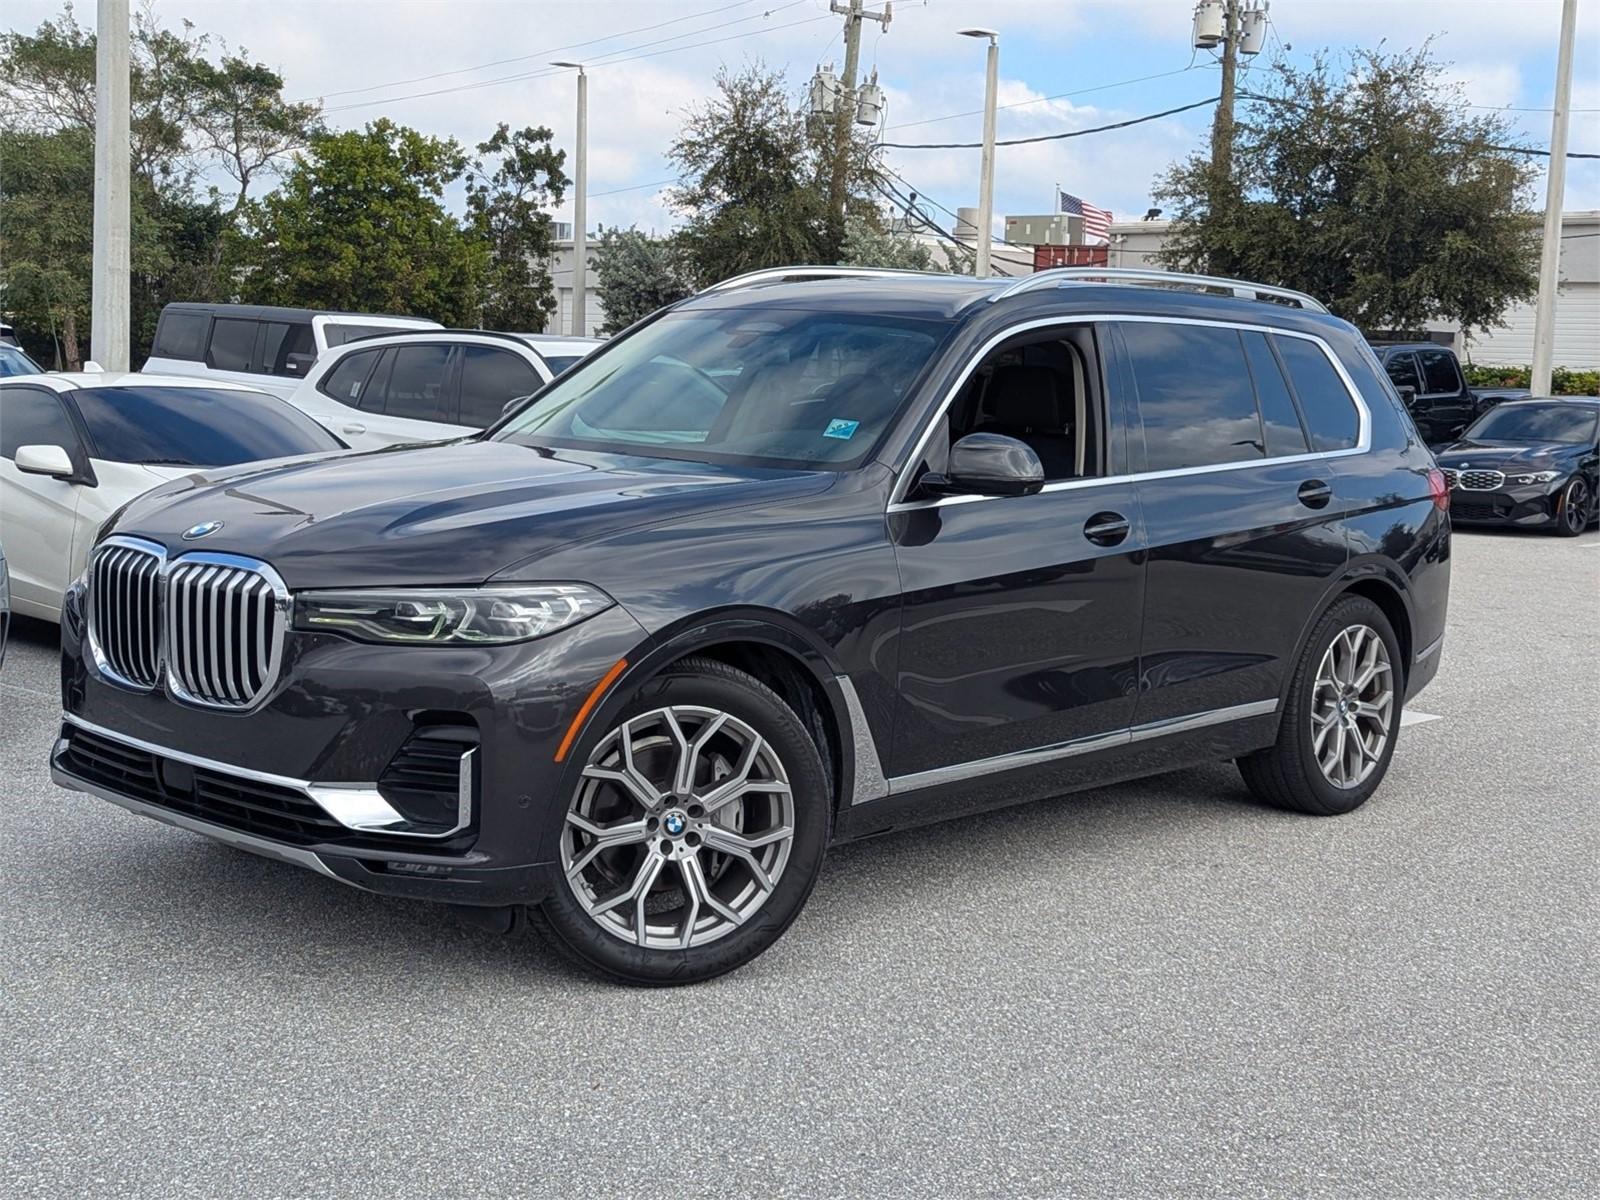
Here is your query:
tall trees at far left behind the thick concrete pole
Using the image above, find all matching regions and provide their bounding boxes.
[0,3,317,362]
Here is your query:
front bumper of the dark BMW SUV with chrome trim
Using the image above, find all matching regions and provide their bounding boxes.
[51,594,645,906]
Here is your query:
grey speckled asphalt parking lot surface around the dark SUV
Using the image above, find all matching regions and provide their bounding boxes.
[0,533,1600,1197]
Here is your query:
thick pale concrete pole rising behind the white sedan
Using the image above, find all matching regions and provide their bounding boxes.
[90,0,131,371]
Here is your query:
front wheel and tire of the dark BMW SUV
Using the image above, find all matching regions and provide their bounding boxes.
[530,658,832,987]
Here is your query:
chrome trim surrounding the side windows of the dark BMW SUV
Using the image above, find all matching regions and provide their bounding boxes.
[886,312,1373,512]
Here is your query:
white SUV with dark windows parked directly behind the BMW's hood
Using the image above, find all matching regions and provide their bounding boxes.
[288,330,600,450]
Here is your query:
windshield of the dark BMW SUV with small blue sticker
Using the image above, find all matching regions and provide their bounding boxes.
[494,309,947,469]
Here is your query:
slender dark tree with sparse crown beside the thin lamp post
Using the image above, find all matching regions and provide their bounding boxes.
[467,122,571,330]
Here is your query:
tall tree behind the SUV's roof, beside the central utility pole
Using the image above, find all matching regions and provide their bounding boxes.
[667,64,878,285]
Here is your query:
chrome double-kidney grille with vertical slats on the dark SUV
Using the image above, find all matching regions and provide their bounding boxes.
[86,536,290,709]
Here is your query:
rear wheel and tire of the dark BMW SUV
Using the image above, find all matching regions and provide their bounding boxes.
[1238,595,1405,816]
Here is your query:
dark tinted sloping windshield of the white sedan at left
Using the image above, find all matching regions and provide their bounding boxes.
[74,387,344,467]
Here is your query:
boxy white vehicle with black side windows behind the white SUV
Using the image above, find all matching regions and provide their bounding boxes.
[139,304,440,400]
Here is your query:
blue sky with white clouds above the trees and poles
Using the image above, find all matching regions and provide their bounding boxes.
[12,0,1600,229]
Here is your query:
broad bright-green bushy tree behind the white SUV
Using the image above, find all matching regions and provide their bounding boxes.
[234,120,488,325]
